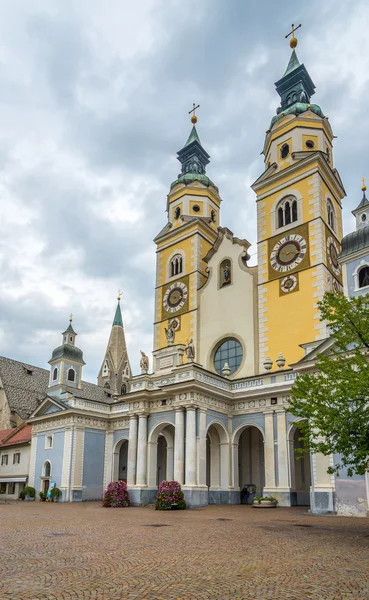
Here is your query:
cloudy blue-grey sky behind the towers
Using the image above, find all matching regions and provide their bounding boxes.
[0,0,369,381]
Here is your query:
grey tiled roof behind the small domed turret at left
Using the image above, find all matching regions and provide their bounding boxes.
[0,356,112,420]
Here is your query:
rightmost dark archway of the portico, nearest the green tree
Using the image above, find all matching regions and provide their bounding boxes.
[288,425,311,506]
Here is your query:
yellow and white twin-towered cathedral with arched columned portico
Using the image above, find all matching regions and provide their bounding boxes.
[13,38,369,514]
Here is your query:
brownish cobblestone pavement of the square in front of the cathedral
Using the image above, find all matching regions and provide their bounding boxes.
[0,502,369,600]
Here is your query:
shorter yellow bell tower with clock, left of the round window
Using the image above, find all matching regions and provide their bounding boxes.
[154,105,221,369]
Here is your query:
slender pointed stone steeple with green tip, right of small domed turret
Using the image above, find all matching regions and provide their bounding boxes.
[98,292,132,396]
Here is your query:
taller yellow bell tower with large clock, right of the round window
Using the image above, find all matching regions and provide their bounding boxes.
[252,26,345,371]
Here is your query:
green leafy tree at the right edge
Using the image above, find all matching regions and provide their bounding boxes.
[289,292,369,476]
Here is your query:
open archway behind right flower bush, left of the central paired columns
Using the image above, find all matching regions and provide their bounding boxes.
[147,423,174,487]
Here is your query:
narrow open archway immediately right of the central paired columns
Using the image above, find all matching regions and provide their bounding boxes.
[206,423,229,496]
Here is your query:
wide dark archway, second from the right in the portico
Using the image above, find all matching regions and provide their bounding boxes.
[233,425,265,496]
